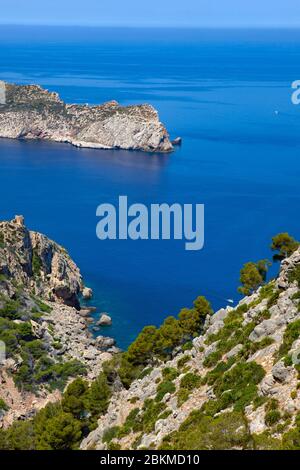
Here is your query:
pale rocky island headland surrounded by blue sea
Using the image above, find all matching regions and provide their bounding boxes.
[0,82,172,152]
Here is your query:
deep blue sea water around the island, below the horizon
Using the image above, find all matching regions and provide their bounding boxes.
[0,26,300,348]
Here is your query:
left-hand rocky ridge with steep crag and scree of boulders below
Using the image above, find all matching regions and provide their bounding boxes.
[0,216,117,427]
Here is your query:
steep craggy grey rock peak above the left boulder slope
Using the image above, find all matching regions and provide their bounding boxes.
[0,216,83,309]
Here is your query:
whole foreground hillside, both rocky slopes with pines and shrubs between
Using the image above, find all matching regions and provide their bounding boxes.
[0,218,300,450]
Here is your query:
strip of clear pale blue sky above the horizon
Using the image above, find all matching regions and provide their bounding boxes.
[0,0,300,27]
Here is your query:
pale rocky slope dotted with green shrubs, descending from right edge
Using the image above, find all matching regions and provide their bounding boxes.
[81,249,300,450]
